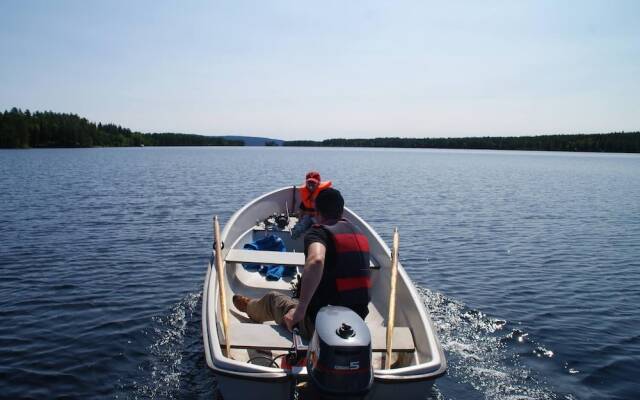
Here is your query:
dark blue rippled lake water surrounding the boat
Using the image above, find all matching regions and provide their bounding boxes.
[0,148,640,400]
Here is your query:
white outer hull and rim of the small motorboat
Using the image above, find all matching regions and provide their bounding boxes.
[202,188,446,400]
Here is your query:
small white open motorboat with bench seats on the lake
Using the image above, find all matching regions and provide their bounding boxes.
[202,187,446,400]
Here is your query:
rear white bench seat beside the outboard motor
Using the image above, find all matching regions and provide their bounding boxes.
[220,322,415,353]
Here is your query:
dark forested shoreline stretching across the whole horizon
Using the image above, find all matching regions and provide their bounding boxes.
[0,107,640,153]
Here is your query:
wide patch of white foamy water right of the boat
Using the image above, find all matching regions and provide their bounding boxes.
[418,286,557,399]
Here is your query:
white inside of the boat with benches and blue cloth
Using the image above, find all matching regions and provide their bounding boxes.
[216,216,430,369]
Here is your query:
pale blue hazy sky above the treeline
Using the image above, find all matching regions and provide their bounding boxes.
[0,0,640,140]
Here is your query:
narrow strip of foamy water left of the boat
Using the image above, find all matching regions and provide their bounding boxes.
[137,293,202,399]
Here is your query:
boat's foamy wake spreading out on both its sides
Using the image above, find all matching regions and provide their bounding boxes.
[122,285,564,400]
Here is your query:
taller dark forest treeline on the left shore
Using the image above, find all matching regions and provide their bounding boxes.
[0,108,244,148]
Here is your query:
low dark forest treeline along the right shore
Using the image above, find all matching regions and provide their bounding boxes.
[284,132,640,153]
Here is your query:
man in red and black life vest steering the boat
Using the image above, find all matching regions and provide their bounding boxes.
[233,188,371,339]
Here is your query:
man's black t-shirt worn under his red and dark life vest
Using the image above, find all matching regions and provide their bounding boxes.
[303,225,369,322]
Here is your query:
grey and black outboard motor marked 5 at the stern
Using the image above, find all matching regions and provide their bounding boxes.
[307,306,373,397]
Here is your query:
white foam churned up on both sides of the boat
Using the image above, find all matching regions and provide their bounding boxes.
[129,286,567,400]
